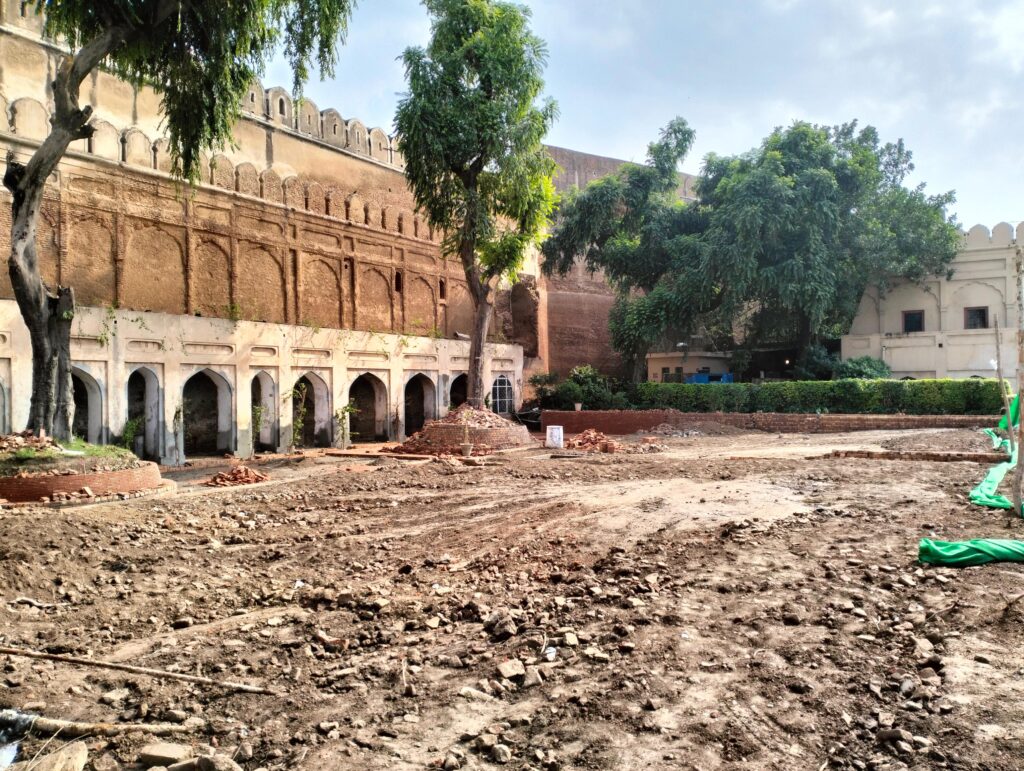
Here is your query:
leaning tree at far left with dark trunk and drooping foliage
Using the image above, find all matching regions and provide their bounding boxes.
[3,0,353,439]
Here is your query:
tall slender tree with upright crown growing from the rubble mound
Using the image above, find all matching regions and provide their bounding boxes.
[395,0,556,408]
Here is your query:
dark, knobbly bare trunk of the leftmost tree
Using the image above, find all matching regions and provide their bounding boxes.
[3,27,127,439]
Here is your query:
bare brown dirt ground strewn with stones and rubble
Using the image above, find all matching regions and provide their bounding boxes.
[0,431,1024,771]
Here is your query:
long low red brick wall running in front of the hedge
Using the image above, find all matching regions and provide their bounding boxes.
[541,410,999,434]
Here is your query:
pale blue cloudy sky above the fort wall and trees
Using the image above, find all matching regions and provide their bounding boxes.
[263,0,1024,228]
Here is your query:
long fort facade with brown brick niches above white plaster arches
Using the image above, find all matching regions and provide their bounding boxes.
[0,10,540,456]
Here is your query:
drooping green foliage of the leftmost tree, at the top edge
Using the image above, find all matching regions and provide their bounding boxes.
[33,0,354,181]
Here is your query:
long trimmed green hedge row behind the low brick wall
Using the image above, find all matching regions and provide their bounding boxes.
[636,378,1002,415]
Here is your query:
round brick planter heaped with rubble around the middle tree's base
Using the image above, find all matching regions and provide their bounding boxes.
[381,404,535,456]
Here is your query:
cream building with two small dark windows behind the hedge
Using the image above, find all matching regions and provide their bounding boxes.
[842,222,1024,383]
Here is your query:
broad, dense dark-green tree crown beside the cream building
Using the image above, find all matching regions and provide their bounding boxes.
[545,116,959,376]
